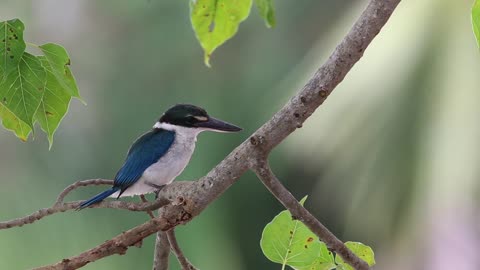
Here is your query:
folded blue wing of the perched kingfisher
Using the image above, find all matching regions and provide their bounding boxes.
[114,129,175,192]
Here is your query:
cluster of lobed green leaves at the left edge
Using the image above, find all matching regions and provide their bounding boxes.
[0,19,80,146]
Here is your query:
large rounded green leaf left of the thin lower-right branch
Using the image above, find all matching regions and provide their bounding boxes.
[260,197,335,270]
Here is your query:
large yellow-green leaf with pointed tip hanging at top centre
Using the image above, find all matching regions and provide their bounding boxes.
[190,0,252,66]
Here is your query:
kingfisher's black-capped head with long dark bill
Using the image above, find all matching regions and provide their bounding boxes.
[154,104,242,132]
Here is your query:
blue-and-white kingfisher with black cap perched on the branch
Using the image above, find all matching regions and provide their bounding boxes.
[78,104,242,210]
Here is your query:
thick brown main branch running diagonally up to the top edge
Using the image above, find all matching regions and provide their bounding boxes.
[14,0,400,269]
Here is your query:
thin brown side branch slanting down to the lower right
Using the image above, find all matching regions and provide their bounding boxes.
[253,159,369,270]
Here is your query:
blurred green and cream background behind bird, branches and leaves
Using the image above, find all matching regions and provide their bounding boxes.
[0,0,480,270]
